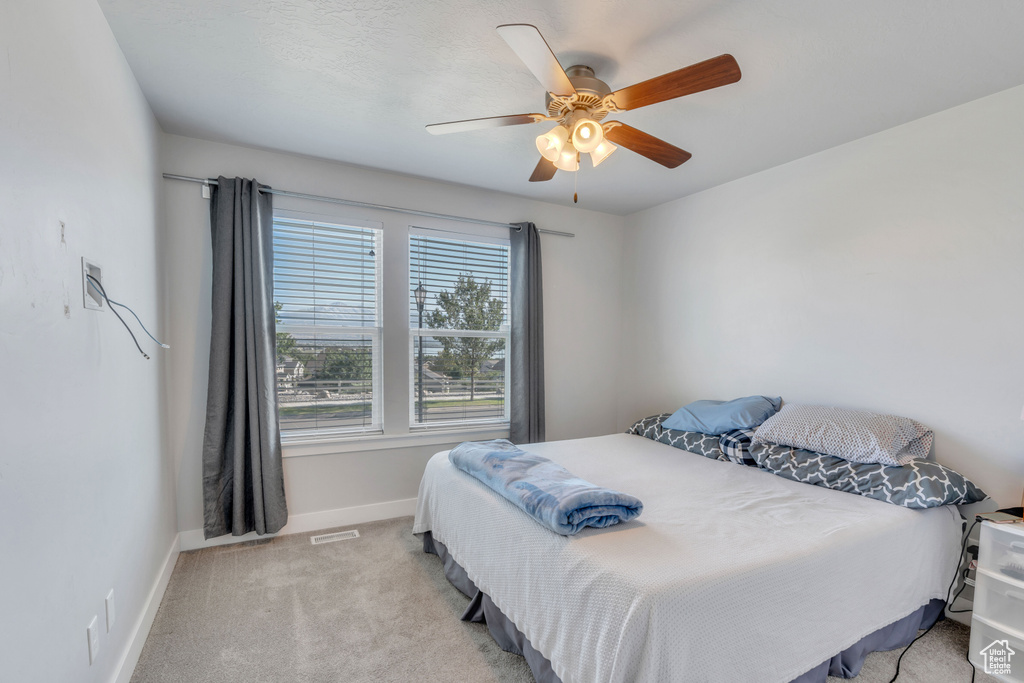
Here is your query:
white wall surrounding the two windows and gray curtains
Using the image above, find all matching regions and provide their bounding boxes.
[162,135,624,547]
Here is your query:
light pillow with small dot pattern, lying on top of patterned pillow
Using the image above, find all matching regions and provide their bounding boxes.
[754,403,933,465]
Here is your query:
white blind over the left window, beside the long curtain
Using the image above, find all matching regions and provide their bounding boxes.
[273,216,381,436]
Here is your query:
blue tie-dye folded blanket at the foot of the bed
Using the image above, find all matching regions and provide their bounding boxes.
[449,438,643,536]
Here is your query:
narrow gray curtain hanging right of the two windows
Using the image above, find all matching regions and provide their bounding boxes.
[508,223,545,443]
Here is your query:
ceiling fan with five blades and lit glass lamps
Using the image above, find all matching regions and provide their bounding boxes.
[427,24,740,187]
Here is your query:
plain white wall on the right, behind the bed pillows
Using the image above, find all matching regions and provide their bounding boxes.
[618,86,1024,505]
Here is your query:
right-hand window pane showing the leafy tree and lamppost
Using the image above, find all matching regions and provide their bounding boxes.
[409,230,509,427]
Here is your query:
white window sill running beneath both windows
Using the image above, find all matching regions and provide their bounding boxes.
[281,424,509,458]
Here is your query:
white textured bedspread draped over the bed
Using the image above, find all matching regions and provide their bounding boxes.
[413,434,961,683]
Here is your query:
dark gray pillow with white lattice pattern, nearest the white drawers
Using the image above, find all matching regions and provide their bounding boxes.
[751,443,988,509]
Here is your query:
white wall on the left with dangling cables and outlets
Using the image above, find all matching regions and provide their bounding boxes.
[0,0,176,682]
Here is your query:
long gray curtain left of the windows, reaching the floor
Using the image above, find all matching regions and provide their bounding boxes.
[203,177,288,539]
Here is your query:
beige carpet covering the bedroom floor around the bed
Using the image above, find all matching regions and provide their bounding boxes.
[131,517,993,683]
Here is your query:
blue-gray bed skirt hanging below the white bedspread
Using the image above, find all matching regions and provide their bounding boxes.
[423,531,945,683]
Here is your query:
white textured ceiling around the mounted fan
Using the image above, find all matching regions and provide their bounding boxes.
[99,0,1024,214]
